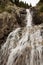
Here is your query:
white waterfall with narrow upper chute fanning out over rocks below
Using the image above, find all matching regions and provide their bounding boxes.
[0,9,43,65]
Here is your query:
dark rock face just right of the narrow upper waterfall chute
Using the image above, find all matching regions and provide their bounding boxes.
[30,7,42,25]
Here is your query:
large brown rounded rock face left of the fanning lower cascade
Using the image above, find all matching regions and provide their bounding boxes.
[0,12,18,47]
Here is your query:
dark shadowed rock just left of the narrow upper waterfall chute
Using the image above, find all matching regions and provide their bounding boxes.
[16,9,27,27]
